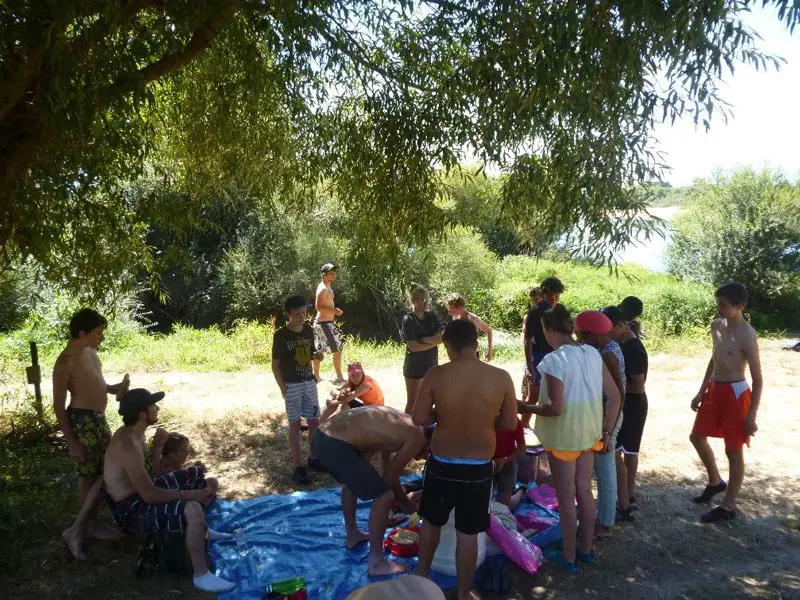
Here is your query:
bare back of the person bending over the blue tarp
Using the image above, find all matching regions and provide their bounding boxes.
[319,406,418,452]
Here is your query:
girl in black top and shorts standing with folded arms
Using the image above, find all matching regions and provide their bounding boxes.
[400,283,444,414]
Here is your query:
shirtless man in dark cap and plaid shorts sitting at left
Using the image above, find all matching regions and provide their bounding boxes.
[103,388,236,593]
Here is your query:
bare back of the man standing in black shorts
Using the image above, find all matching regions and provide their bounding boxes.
[418,358,516,460]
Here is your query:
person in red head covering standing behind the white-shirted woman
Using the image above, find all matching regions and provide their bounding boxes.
[575,310,625,538]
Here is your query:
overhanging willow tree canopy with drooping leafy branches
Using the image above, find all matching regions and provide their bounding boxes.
[0,0,800,296]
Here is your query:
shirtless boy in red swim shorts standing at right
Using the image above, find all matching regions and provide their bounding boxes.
[689,283,762,523]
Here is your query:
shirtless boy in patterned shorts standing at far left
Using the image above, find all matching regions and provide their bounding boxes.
[53,308,129,559]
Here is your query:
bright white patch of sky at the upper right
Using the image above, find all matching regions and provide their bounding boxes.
[654,7,800,185]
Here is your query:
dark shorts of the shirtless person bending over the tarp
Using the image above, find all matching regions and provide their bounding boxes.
[311,429,389,500]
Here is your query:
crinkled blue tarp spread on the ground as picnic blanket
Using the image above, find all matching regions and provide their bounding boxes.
[203,476,560,600]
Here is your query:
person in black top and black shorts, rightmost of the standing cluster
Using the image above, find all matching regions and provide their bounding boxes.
[603,306,647,521]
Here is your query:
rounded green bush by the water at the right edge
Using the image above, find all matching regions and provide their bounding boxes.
[668,169,800,324]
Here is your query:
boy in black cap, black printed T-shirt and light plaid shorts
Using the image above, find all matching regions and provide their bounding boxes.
[272,296,322,485]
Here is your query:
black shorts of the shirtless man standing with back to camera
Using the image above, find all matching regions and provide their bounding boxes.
[419,455,494,535]
